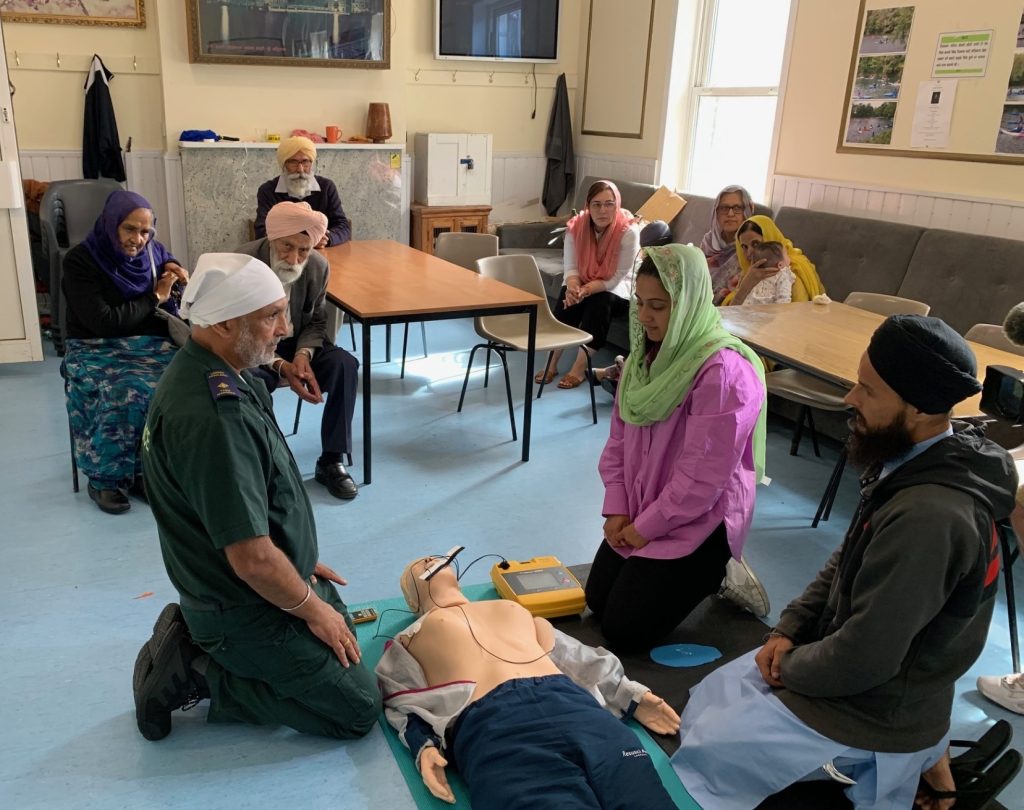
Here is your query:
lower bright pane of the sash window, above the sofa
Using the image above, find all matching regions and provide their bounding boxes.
[687,95,777,203]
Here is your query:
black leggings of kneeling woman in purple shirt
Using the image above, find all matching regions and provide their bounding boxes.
[586,524,732,652]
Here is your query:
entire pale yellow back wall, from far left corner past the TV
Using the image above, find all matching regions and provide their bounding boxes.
[3,0,586,154]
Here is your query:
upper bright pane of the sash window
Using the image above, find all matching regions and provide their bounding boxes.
[705,0,790,87]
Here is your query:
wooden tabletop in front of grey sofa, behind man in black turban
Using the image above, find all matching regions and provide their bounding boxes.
[719,301,1024,417]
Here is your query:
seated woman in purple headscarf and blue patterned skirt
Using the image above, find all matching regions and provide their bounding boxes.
[61,190,188,514]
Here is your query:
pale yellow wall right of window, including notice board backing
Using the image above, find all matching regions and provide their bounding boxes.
[775,0,1024,200]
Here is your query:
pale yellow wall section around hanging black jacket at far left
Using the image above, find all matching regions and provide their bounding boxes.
[3,20,163,150]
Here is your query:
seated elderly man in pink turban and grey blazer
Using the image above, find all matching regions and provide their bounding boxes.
[238,202,359,501]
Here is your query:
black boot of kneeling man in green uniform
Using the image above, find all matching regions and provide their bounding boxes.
[132,602,210,739]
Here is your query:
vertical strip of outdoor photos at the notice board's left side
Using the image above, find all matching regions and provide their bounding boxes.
[844,6,913,146]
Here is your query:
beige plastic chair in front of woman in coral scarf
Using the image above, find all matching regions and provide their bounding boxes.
[458,254,597,441]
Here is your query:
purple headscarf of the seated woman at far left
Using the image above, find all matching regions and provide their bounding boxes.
[82,190,176,307]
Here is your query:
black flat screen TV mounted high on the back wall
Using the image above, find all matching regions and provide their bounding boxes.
[434,0,560,61]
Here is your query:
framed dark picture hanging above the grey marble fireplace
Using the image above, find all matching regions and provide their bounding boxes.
[185,0,391,69]
